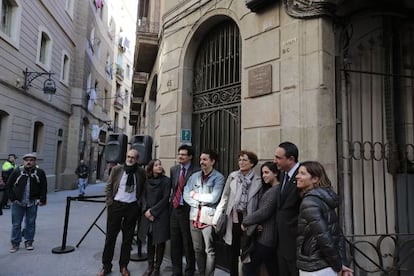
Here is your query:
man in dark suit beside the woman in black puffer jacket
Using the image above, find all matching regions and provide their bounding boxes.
[274,142,301,276]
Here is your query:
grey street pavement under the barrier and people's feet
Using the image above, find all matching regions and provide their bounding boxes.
[0,183,228,276]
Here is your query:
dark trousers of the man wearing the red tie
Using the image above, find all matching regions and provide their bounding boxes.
[170,207,195,276]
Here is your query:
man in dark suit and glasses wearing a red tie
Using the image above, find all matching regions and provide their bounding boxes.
[170,145,198,276]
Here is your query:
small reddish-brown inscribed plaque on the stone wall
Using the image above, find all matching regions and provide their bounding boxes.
[248,64,272,97]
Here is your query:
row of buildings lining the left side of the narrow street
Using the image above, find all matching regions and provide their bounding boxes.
[0,0,138,190]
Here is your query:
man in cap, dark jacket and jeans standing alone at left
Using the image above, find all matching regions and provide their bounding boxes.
[6,152,47,253]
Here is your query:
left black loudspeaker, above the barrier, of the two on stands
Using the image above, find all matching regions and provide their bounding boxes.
[105,133,128,163]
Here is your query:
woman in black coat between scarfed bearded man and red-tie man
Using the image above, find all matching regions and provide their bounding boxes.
[138,159,171,276]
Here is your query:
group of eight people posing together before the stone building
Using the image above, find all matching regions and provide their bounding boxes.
[98,142,352,276]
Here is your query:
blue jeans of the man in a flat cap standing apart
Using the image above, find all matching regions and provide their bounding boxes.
[11,202,37,245]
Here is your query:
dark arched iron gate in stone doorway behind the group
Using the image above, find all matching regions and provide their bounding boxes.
[192,21,241,176]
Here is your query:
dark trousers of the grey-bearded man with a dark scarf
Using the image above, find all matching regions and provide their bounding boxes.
[102,201,139,270]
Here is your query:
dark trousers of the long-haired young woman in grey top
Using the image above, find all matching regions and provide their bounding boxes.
[243,242,282,276]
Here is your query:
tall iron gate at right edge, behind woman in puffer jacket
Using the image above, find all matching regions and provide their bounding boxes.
[337,14,414,275]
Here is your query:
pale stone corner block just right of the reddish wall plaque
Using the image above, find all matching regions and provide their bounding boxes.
[280,56,299,92]
